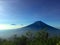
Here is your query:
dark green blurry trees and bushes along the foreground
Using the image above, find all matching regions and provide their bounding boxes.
[0,31,60,45]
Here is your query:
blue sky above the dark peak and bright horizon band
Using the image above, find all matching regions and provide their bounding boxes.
[0,0,60,27]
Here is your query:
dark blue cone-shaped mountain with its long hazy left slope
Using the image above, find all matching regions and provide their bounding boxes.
[0,21,60,38]
